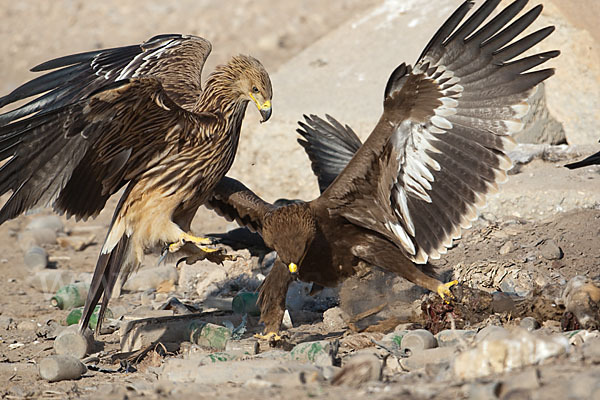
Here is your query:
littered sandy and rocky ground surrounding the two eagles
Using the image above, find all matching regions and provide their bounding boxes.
[0,0,600,399]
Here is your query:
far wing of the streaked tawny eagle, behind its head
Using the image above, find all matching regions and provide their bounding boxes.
[0,34,212,125]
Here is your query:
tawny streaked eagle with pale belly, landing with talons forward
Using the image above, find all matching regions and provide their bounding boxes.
[0,35,272,331]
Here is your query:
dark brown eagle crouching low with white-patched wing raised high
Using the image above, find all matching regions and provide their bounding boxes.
[208,0,559,332]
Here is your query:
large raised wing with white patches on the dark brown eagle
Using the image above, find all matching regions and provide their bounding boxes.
[313,0,559,263]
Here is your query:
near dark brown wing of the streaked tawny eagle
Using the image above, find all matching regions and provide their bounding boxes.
[0,77,218,223]
